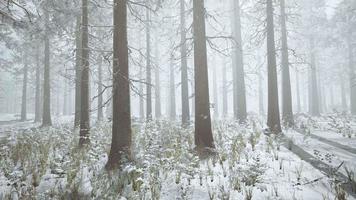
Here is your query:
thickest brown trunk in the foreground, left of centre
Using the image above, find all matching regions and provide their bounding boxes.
[106,0,131,170]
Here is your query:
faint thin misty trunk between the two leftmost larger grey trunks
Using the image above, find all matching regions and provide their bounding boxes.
[35,44,42,122]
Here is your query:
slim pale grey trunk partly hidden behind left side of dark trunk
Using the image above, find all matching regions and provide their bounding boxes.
[74,15,82,127]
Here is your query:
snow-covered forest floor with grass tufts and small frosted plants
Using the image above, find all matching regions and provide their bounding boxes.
[0,114,356,200]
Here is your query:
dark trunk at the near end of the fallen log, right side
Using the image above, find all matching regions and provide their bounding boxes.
[267,0,282,133]
